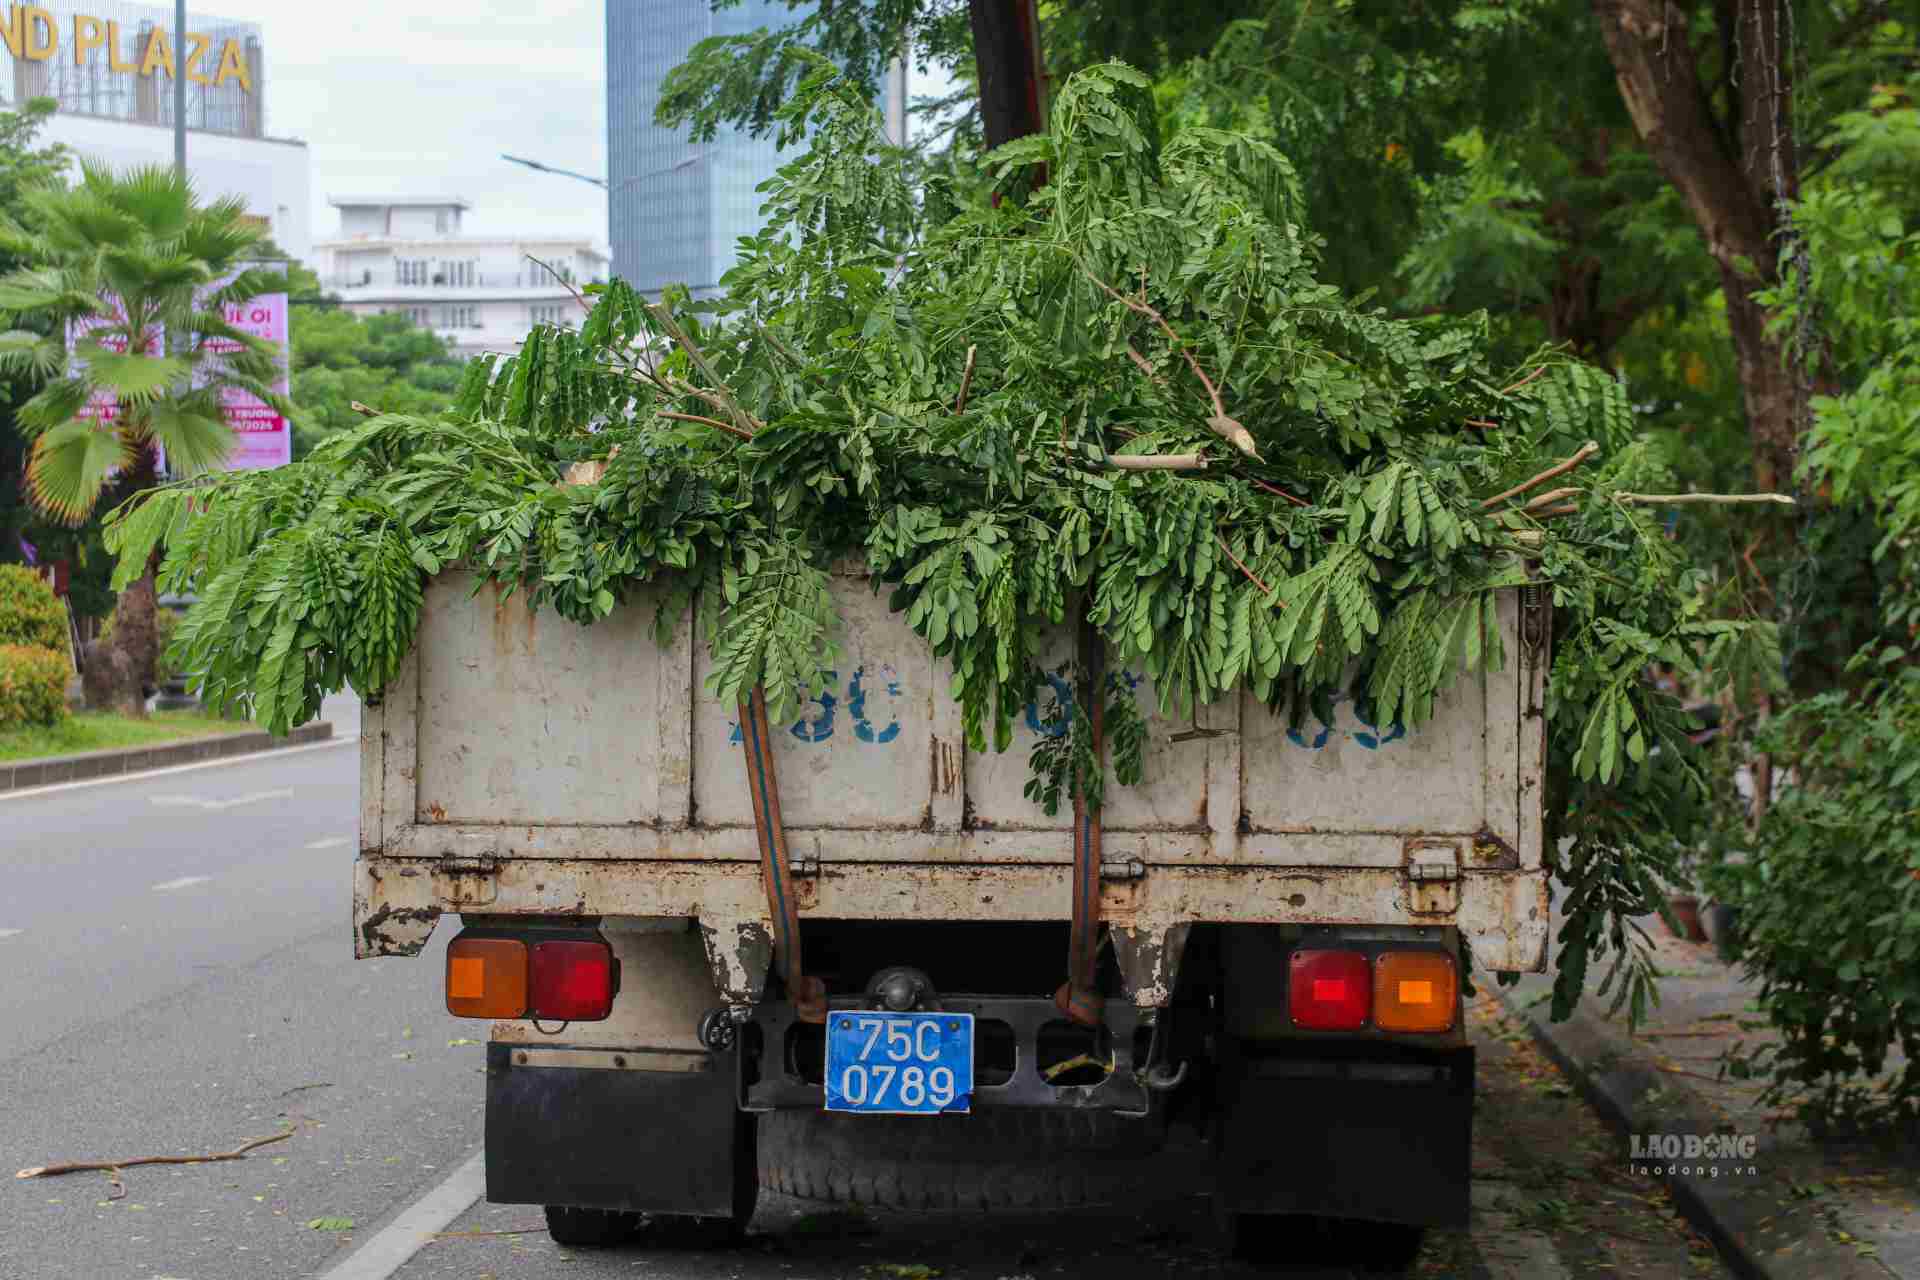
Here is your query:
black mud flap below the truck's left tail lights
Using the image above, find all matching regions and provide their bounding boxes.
[486,1044,755,1219]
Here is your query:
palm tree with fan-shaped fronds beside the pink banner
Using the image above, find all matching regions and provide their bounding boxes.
[0,163,290,716]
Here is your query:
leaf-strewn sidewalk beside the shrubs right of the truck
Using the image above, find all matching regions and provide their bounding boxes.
[1494,917,1920,1280]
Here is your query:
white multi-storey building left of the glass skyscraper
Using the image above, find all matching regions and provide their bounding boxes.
[313,196,607,355]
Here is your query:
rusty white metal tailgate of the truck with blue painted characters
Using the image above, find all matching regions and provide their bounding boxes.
[353,574,1548,998]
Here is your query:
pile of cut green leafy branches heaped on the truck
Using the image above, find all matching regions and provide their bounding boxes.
[111,63,1776,1009]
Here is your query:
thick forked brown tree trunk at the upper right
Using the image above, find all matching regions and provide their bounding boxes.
[1594,0,1807,489]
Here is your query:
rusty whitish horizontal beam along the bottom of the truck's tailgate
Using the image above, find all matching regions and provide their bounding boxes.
[353,859,1549,982]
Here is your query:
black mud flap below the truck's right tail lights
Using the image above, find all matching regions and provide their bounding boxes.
[1215,1042,1475,1226]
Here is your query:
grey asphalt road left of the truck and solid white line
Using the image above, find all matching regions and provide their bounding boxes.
[0,702,486,1280]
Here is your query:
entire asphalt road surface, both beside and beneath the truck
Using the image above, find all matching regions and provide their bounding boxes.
[0,704,1720,1280]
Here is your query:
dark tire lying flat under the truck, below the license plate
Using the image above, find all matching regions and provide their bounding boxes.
[758,1107,1164,1209]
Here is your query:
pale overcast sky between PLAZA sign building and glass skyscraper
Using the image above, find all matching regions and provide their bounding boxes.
[211,0,609,244]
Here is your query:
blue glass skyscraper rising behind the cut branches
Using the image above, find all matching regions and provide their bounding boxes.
[607,0,804,296]
